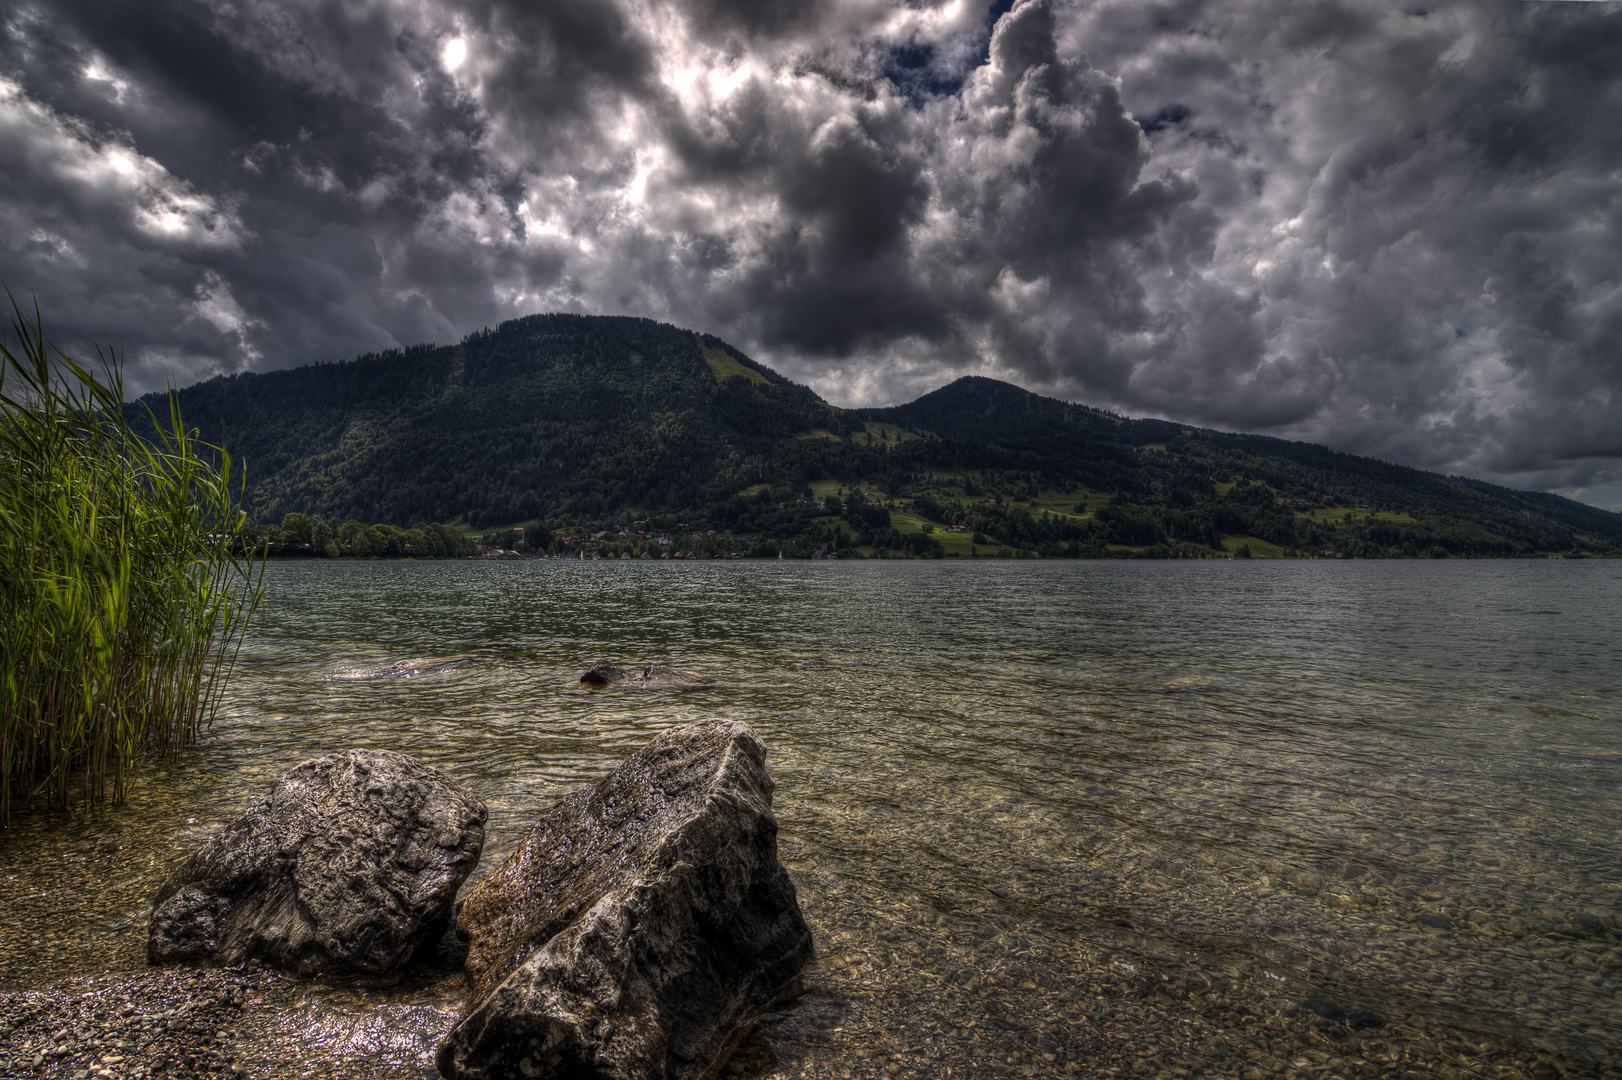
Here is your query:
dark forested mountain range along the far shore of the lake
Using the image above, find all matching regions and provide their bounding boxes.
[143,315,1622,558]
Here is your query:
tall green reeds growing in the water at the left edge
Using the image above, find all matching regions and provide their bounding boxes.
[0,294,261,822]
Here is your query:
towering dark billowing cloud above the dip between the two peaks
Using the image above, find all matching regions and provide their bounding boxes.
[658,3,1192,399]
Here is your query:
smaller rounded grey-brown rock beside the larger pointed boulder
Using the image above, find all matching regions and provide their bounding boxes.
[146,751,487,979]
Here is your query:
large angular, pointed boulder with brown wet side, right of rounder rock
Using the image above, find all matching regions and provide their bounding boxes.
[436,720,811,1080]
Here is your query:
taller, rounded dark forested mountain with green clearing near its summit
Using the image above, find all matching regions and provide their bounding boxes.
[145,315,853,524]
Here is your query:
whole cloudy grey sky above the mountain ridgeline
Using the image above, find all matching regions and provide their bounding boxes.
[0,0,1622,508]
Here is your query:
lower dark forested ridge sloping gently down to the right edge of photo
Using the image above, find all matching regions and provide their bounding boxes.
[863,378,1622,555]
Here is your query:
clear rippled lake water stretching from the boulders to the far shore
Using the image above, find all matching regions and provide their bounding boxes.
[0,561,1622,1080]
